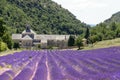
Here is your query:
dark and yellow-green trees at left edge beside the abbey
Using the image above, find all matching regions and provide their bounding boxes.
[0,18,13,52]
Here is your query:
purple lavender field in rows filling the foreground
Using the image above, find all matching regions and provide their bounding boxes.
[0,47,120,80]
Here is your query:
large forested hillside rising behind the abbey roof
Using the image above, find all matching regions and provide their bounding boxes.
[0,0,88,34]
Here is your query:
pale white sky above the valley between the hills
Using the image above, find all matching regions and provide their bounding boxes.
[53,0,120,24]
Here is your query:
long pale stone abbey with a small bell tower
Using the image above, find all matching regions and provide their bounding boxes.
[12,26,70,48]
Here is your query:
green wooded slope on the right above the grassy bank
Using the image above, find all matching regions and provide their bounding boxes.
[89,12,120,43]
